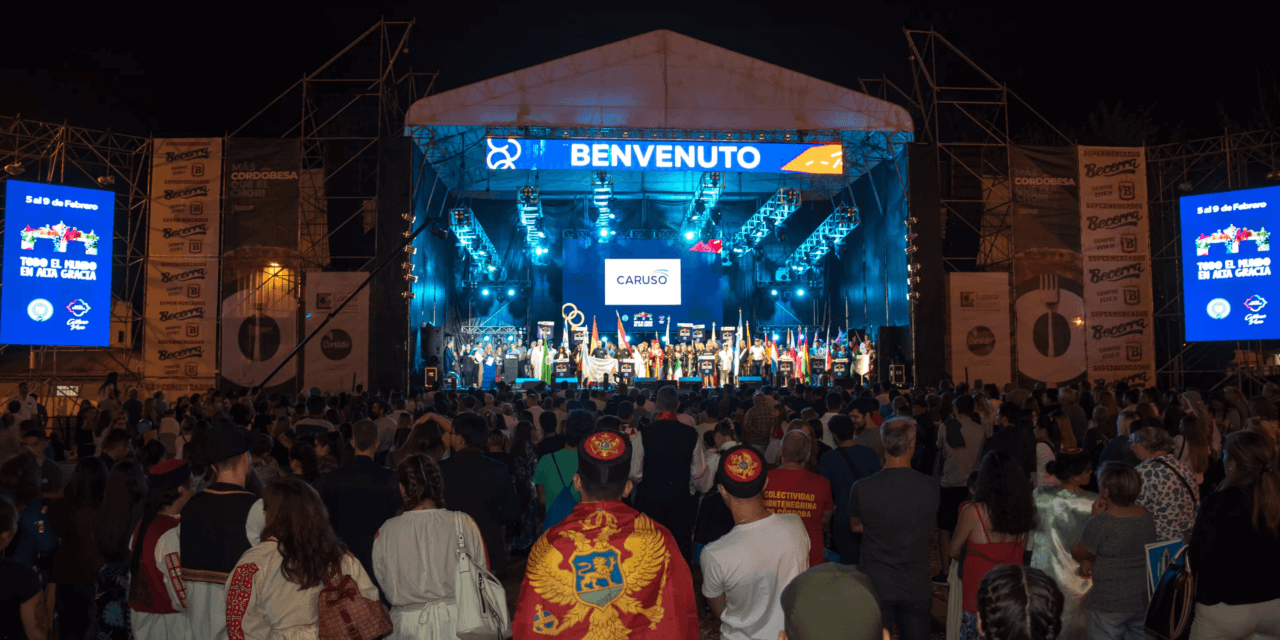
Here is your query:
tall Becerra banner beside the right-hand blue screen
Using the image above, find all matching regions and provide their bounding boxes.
[1080,147,1156,387]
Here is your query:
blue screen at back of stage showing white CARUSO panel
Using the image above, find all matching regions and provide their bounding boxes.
[561,238,724,327]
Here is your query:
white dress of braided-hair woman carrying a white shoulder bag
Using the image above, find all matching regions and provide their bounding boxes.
[374,509,489,640]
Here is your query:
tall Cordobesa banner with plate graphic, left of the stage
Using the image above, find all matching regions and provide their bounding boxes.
[220,138,301,392]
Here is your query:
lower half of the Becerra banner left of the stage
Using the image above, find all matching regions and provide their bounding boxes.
[143,257,218,376]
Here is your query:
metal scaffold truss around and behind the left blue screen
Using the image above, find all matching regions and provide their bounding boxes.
[0,116,151,404]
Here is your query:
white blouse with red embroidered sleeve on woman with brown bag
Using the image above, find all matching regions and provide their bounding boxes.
[227,540,378,640]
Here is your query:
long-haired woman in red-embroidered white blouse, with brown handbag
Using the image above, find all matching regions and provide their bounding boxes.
[225,478,378,640]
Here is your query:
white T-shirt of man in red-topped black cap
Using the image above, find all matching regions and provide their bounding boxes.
[701,513,809,640]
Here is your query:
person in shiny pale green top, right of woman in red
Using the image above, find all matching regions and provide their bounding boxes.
[1030,448,1098,640]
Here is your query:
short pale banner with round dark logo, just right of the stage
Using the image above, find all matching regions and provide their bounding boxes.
[950,273,1014,387]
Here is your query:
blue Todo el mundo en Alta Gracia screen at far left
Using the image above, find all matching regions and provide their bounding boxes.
[0,180,115,347]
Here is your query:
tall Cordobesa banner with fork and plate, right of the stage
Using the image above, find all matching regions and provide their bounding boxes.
[1009,147,1085,389]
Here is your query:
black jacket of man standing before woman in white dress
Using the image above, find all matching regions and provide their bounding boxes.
[439,448,520,573]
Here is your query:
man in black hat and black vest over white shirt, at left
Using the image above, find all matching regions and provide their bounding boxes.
[178,422,264,640]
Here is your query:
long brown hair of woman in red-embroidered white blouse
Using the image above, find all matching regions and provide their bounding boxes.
[262,476,347,589]
